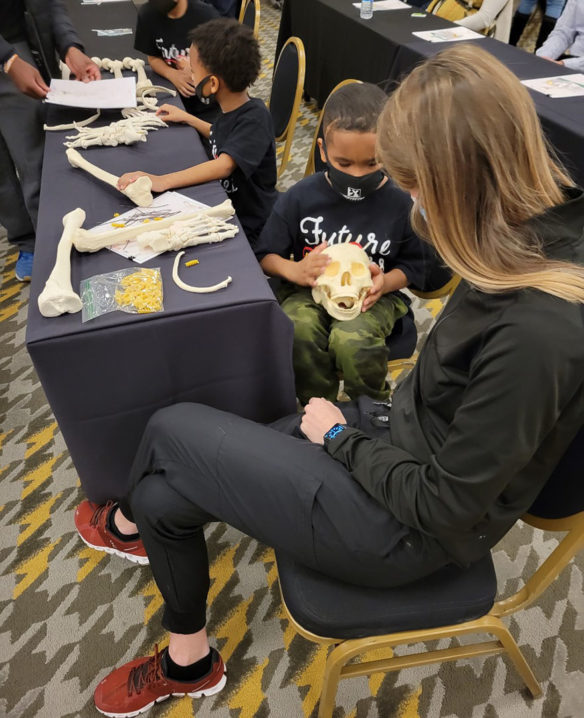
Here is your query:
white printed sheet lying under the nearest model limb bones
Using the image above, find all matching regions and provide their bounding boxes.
[89,192,209,264]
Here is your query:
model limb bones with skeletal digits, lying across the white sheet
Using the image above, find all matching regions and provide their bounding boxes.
[73,199,238,252]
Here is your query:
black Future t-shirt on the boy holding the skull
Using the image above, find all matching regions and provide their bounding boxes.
[254,172,424,284]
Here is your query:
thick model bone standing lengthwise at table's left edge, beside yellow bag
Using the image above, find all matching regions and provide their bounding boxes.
[38,207,85,317]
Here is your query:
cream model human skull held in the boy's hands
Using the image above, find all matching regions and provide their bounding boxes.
[312,242,373,320]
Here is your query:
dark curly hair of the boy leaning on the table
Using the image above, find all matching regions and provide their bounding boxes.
[189,18,261,92]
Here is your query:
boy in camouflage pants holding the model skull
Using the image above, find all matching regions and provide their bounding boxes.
[254,83,423,404]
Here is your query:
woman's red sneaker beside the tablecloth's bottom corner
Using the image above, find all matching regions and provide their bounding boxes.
[75,499,148,564]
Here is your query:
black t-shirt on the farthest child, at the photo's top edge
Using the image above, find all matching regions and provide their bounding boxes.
[134,0,219,115]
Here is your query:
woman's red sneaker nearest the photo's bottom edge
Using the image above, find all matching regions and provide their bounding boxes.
[93,646,227,718]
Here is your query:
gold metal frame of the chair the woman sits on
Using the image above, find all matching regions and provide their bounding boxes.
[282,511,584,718]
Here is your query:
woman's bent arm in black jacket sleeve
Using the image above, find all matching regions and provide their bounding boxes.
[327,306,583,539]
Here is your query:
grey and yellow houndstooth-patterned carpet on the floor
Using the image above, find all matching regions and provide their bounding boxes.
[0,3,584,718]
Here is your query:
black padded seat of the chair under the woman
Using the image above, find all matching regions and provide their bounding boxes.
[277,552,497,639]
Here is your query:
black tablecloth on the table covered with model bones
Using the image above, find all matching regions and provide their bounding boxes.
[26,97,296,501]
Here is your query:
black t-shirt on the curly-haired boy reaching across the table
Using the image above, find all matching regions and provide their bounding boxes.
[209,97,278,243]
